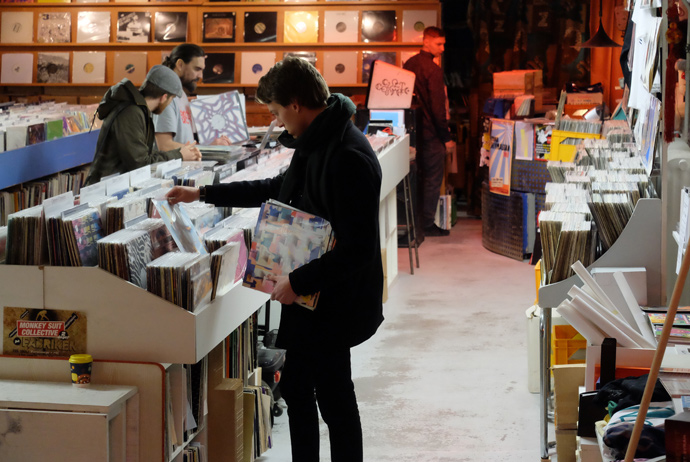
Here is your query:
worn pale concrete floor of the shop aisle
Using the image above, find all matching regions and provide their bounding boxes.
[258,218,544,462]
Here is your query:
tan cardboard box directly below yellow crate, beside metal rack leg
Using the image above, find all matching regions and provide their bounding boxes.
[552,364,585,430]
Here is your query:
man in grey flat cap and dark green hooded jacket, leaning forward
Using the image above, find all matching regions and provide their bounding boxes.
[86,64,201,185]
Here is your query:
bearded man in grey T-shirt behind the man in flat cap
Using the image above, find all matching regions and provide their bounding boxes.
[153,43,230,151]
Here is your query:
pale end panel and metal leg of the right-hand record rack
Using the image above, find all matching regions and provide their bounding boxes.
[539,199,662,460]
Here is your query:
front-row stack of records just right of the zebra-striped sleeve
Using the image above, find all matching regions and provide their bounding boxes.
[146,252,213,312]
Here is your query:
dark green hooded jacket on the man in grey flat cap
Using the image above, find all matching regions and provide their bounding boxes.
[86,79,182,185]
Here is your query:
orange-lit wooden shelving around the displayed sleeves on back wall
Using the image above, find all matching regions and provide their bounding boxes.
[0,0,441,102]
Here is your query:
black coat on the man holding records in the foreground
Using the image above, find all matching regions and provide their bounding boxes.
[206,94,383,348]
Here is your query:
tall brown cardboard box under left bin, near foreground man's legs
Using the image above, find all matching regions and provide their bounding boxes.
[208,379,243,462]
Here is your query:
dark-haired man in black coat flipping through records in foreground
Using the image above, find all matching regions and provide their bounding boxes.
[167,58,383,462]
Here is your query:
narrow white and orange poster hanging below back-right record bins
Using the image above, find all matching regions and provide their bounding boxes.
[489,119,515,196]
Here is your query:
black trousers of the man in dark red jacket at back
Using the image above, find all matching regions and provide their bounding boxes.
[417,138,446,228]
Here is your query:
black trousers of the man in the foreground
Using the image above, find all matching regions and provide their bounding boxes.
[280,346,363,462]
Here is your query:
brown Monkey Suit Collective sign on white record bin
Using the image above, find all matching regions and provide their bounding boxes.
[2,306,88,356]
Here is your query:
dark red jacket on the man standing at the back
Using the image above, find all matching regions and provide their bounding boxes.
[403,50,451,143]
